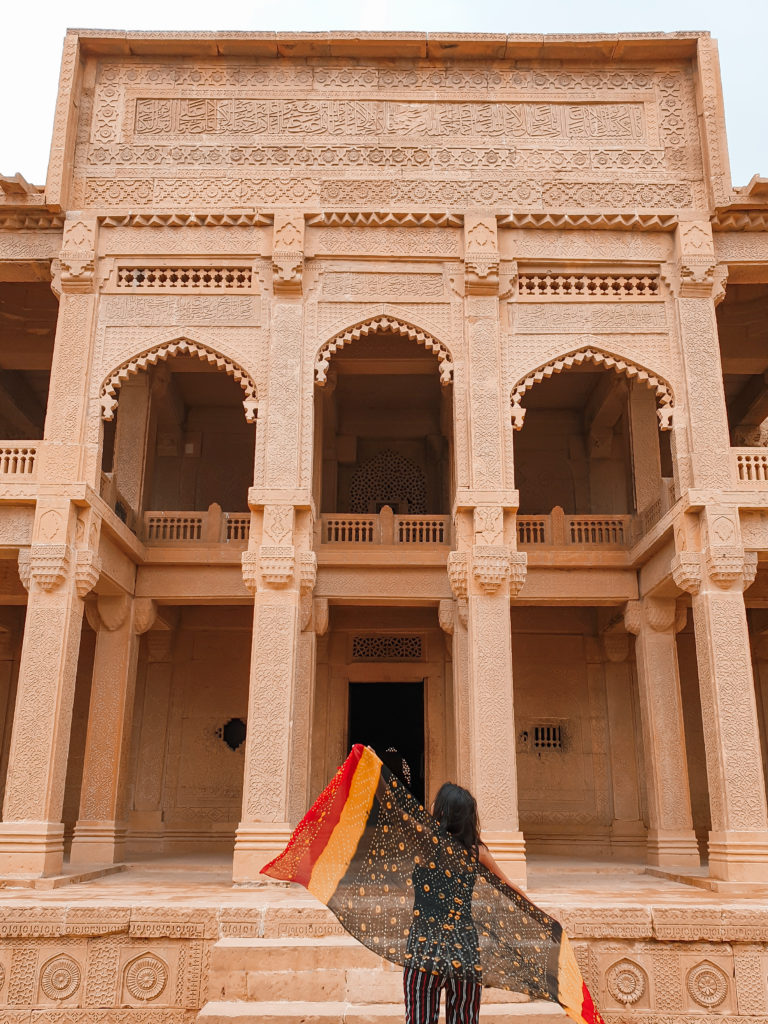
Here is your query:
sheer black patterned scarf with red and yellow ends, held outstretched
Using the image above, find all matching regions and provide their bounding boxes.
[262,744,602,1024]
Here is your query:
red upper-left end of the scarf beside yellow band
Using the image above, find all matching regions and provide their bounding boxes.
[261,743,365,888]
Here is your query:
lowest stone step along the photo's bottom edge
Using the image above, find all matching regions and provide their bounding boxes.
[198,1000,565,1024]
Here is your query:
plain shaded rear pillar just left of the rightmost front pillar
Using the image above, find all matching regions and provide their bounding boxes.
[624,597,699,866]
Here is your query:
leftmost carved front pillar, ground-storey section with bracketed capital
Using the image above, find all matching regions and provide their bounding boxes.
[0,498,98,876]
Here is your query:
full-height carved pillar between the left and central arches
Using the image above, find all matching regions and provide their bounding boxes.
[232,211,316,882]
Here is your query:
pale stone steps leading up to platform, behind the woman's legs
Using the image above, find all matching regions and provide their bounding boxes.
[198,935,564,1024]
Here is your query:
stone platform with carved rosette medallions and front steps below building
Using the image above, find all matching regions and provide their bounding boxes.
[0,857,768,1024]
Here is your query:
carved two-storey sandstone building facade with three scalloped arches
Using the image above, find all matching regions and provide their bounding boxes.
[0,32,768,1020]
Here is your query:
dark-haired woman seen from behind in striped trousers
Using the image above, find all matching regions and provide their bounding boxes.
[402,782,523,1024]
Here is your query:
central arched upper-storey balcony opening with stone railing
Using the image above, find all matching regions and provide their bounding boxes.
[314,332,453,565]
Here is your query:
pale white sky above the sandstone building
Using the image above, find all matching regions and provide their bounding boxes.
[0,0,768,185]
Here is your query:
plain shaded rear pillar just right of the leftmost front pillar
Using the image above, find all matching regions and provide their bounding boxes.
[70,595,155,864]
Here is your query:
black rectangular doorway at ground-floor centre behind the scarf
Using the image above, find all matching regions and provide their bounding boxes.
[349,680,424,803]
